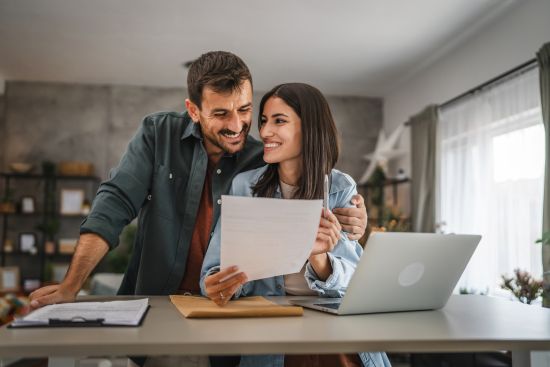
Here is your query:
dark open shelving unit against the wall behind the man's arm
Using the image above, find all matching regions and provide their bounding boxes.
[0,173,100,289]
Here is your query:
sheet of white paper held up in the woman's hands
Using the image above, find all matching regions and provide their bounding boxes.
[221,196,323,281]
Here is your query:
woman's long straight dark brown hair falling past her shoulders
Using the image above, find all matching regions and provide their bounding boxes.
[252,83,340,199]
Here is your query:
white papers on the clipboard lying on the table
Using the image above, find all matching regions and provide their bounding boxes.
[11,298,149,327]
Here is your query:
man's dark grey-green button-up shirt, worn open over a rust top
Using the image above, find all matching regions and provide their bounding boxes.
[80,112,265,295]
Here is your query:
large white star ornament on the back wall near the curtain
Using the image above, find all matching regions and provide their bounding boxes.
[359,123,406,185]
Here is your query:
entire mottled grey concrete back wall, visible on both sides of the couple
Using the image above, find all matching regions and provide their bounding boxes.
[0,81,383,183]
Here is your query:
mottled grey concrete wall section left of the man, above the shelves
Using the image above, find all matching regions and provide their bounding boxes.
[3,82,185,178]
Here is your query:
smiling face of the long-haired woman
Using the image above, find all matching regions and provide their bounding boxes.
[260,96,302,179]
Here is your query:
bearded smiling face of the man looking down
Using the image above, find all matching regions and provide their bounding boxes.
[185,80,252,156]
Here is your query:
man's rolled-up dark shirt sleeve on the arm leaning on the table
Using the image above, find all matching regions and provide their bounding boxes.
[80,117,155,249]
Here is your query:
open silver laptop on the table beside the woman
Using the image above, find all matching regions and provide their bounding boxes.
[290,232,481,315]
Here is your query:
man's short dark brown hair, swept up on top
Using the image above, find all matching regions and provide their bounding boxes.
[187,51,252,108]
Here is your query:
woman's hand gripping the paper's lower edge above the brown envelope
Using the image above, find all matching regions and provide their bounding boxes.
[204,266,247,306]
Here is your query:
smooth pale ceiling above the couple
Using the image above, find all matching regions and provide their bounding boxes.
[0,0,517,96]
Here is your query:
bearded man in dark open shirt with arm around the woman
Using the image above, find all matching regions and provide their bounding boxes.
[31,51,367,364]
